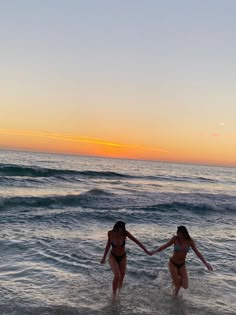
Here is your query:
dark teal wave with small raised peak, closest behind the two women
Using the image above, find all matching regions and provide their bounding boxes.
[0,189,236,213]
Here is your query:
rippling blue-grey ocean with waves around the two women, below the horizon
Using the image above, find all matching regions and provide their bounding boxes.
[0,150,236,315]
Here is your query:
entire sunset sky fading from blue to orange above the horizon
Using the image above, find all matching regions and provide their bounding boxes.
[0,0,236,167]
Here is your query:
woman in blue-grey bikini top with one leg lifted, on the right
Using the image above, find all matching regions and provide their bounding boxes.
[151,226,213,295]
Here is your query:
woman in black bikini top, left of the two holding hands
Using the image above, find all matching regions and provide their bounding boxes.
[101,221,151,297]
